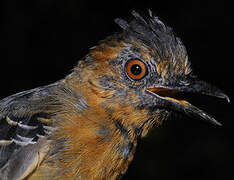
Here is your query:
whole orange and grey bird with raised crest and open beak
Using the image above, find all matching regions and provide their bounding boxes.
[0,10,230,180]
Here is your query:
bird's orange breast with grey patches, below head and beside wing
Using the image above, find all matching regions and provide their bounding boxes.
[48,109,137,179]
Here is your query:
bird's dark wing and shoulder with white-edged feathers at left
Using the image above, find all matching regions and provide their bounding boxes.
[0,83,59,180]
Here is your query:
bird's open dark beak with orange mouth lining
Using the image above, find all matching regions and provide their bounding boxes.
[146,78,230,125]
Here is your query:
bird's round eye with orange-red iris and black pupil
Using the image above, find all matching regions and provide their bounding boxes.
[125,59,147,80]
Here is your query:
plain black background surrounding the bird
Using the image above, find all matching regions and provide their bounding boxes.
[0,0,234,180]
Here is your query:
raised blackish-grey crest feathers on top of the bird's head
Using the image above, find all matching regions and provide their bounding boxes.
[115,10,187,59]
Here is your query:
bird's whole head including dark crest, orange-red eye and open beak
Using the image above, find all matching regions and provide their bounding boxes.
[71,11,229,136]
